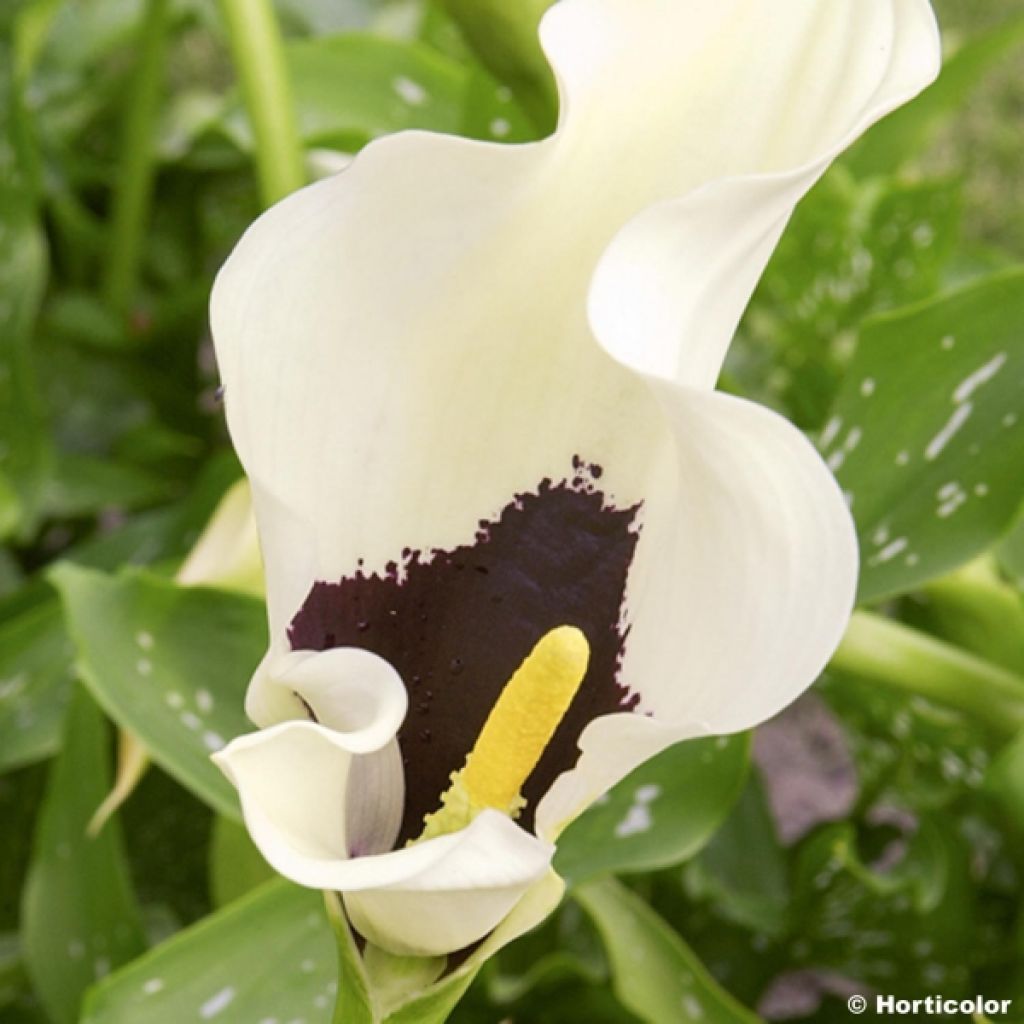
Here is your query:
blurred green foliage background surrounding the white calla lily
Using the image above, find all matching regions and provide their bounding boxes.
[0,0,1024,1024]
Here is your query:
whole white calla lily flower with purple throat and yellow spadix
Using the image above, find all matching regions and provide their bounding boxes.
[212,0,939,955]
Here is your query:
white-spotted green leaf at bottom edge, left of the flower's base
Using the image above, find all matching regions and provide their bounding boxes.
[82,881,336,1024]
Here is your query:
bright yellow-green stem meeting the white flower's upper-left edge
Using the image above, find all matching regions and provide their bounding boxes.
[220,0,306,206]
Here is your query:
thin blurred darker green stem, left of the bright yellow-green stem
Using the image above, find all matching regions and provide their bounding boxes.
[104,0,170,312]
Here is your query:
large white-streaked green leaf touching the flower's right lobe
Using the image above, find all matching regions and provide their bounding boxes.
[820,269,1024,601]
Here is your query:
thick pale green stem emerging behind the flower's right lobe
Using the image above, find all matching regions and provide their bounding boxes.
[830,611,1024,734]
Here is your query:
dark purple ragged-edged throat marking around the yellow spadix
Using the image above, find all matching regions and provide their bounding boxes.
[288,458,639,846]
